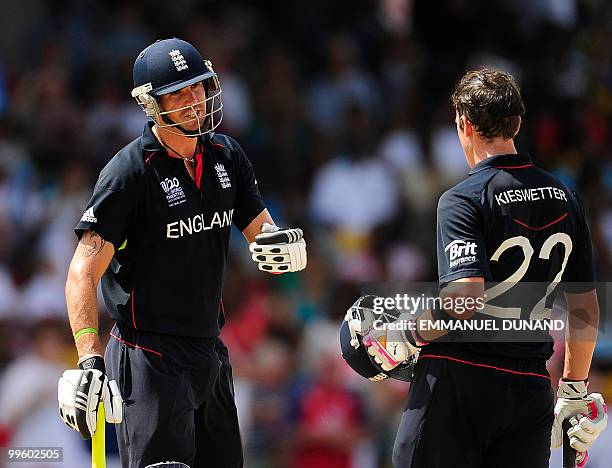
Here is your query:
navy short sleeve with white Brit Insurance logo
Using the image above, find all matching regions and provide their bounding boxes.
[437,192,491,283]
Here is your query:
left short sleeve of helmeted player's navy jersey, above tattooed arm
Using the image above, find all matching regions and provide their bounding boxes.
[75,166,138,249]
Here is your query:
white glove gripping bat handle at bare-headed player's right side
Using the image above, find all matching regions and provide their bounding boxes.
[551,380,608,461]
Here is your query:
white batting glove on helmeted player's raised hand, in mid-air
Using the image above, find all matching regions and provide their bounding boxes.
[249,223,307,274]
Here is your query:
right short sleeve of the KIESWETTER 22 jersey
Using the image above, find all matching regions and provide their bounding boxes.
[561,192,595,293]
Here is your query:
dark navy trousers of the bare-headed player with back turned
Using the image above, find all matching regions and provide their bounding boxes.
[393,356,553,468]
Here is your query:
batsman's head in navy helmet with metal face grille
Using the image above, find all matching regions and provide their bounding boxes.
[132,38,223,137]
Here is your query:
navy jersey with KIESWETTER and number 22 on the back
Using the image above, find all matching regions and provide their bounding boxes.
[430,154,593,359]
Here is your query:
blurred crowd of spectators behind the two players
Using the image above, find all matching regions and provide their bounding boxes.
[0,0,612,468]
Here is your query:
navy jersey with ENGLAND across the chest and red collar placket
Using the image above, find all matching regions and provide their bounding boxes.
[76,122,264,338]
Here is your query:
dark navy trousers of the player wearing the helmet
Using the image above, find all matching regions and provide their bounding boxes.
[105,324,243,468]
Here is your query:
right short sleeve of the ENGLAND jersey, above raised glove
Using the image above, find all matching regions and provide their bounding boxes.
[232,140,266,231]
